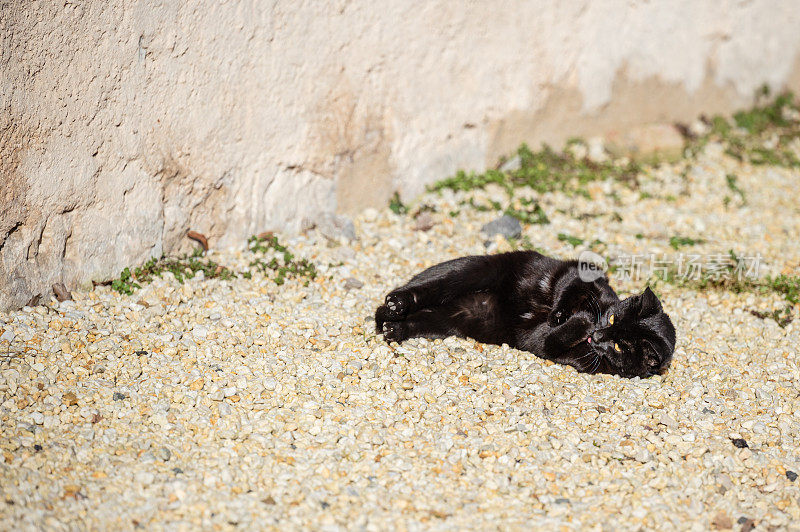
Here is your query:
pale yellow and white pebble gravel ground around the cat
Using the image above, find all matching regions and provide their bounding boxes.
[0,145,800,530]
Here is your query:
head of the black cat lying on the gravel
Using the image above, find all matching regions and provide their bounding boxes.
[588,286,675,377]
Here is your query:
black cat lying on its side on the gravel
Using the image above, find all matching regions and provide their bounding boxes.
[375,251,675,377]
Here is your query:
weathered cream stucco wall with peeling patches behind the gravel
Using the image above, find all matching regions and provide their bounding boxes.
[0,0,800,308]
